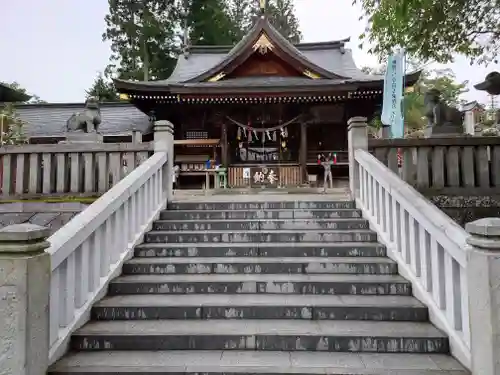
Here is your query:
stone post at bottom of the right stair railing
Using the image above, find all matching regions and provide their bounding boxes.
[465,218,500,375]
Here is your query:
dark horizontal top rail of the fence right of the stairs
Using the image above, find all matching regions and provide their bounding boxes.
[368,135,500,149]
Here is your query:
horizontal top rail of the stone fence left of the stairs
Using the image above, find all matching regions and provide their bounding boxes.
[0,142,153,155]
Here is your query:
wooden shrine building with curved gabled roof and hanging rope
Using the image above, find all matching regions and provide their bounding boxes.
[115,8,419,187]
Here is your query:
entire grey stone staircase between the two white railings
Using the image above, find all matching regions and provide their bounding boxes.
[49,196,468,375]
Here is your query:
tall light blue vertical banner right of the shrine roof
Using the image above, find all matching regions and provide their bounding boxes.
[381,52,405,138]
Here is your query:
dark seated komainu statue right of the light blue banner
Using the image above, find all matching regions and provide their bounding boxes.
[424,89,464,137]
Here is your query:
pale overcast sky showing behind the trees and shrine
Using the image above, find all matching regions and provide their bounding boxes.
[0,0,500,106]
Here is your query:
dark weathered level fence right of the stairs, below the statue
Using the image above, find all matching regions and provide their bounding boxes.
[369,136,500,195]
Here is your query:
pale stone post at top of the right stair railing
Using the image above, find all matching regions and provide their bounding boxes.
[347,117,368,199]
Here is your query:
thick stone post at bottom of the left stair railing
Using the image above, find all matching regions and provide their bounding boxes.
[0,224,50,375]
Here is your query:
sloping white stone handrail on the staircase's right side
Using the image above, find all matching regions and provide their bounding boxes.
[355,149,469,267]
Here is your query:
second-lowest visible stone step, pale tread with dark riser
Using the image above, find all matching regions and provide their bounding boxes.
[70,320,449,353]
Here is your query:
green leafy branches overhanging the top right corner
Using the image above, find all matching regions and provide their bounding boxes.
[354,0,500,63]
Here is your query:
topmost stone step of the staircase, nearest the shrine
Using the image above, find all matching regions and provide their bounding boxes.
[167,200,355,211]
